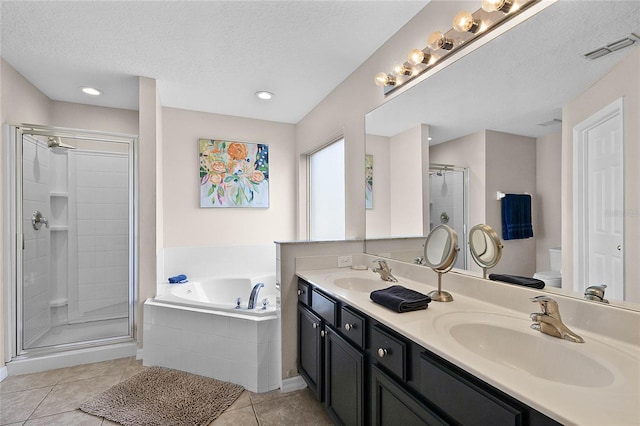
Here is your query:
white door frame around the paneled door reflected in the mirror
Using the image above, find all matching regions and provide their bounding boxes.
[573,97,626,300]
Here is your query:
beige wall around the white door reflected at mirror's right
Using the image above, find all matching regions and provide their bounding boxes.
[562,48,640,303]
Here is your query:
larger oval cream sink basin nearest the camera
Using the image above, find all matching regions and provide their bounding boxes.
[432,313,615,387]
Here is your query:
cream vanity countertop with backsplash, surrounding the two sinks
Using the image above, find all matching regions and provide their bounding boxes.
[296,256,640,425]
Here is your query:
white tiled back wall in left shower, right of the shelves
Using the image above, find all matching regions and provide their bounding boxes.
[69,150,129,320]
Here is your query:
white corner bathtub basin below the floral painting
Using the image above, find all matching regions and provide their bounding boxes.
[154,275,277,317]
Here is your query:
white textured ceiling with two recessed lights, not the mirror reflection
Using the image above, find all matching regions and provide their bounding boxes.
[0,0,427,123]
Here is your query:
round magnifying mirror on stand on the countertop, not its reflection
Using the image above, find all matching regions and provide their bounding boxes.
[424,225,458,302]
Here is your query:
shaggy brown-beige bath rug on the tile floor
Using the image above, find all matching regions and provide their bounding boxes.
[80,367,244,426]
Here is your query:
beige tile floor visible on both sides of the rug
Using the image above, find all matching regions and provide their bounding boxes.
[0,358,333,426]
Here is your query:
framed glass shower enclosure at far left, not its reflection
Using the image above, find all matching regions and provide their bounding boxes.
[9,125,137,358]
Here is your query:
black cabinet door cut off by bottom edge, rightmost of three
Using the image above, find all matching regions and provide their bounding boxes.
[371,365,447,426]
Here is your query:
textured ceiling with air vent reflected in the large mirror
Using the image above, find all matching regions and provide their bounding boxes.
[367,0,640,144]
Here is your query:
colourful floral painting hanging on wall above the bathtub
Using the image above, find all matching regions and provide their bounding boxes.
[199,139,269,207]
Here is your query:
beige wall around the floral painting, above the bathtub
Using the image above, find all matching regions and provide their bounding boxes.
[162,108,298,247]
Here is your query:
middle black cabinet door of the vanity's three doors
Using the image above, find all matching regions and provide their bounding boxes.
[325,327,364,425]
